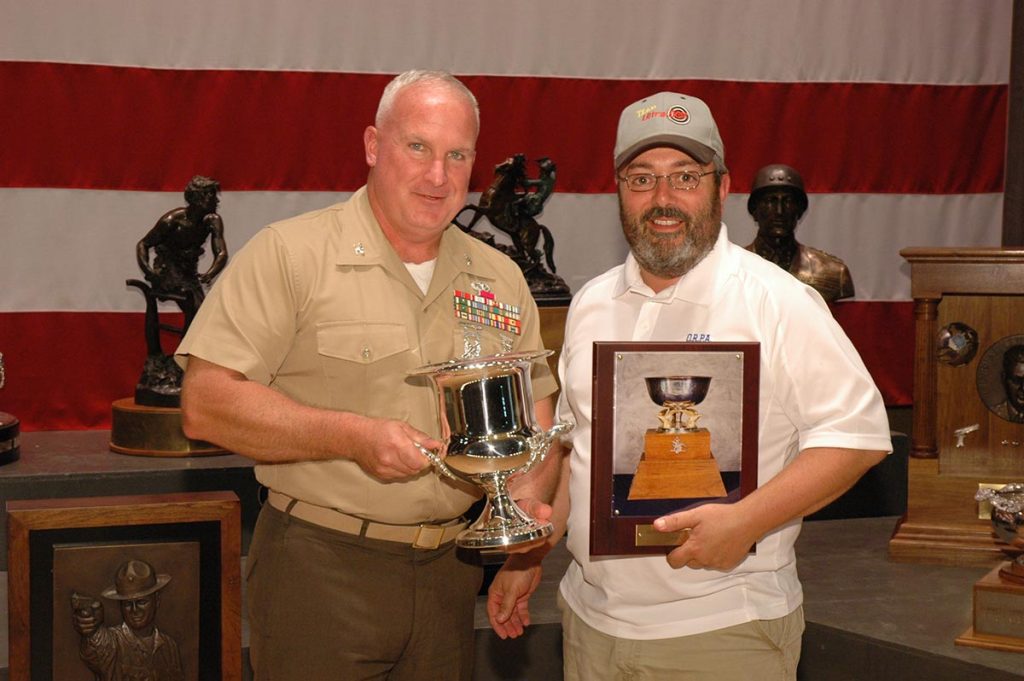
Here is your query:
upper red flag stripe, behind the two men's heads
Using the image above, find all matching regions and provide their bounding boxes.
[0,61,1008,194]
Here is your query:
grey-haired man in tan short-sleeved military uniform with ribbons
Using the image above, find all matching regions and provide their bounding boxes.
[178,72,558,680]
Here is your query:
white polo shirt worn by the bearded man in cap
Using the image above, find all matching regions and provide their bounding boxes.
[559,224,892,639]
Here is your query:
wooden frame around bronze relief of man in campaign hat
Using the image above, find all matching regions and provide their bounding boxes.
[7,492,242,681]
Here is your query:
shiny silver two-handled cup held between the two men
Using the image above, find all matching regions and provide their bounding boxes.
[411,350,571,549]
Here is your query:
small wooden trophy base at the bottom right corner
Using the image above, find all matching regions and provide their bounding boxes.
[956,567,1024,652]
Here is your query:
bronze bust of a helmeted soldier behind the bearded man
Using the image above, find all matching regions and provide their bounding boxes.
[745,163,853,302]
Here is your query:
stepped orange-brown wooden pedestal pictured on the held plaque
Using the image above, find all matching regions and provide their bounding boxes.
[629,428,726,501]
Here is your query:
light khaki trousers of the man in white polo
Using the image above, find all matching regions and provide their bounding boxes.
[558,594,804,681]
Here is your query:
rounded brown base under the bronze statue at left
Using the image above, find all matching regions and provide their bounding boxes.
[110,397,227,457]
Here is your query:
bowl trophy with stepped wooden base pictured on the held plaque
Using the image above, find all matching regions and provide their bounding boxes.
[627,376,726,501]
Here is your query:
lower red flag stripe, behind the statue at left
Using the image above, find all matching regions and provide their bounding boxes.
[0,301,913,431]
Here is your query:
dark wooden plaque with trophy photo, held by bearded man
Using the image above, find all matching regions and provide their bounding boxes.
[590,342,761,556]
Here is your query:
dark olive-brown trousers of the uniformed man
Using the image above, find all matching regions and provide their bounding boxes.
[246,505,483,681]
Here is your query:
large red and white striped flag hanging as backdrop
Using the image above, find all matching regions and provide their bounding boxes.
[0,0,1012,430]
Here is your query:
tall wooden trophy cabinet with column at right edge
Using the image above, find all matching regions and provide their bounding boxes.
[889,248,1024,566]
